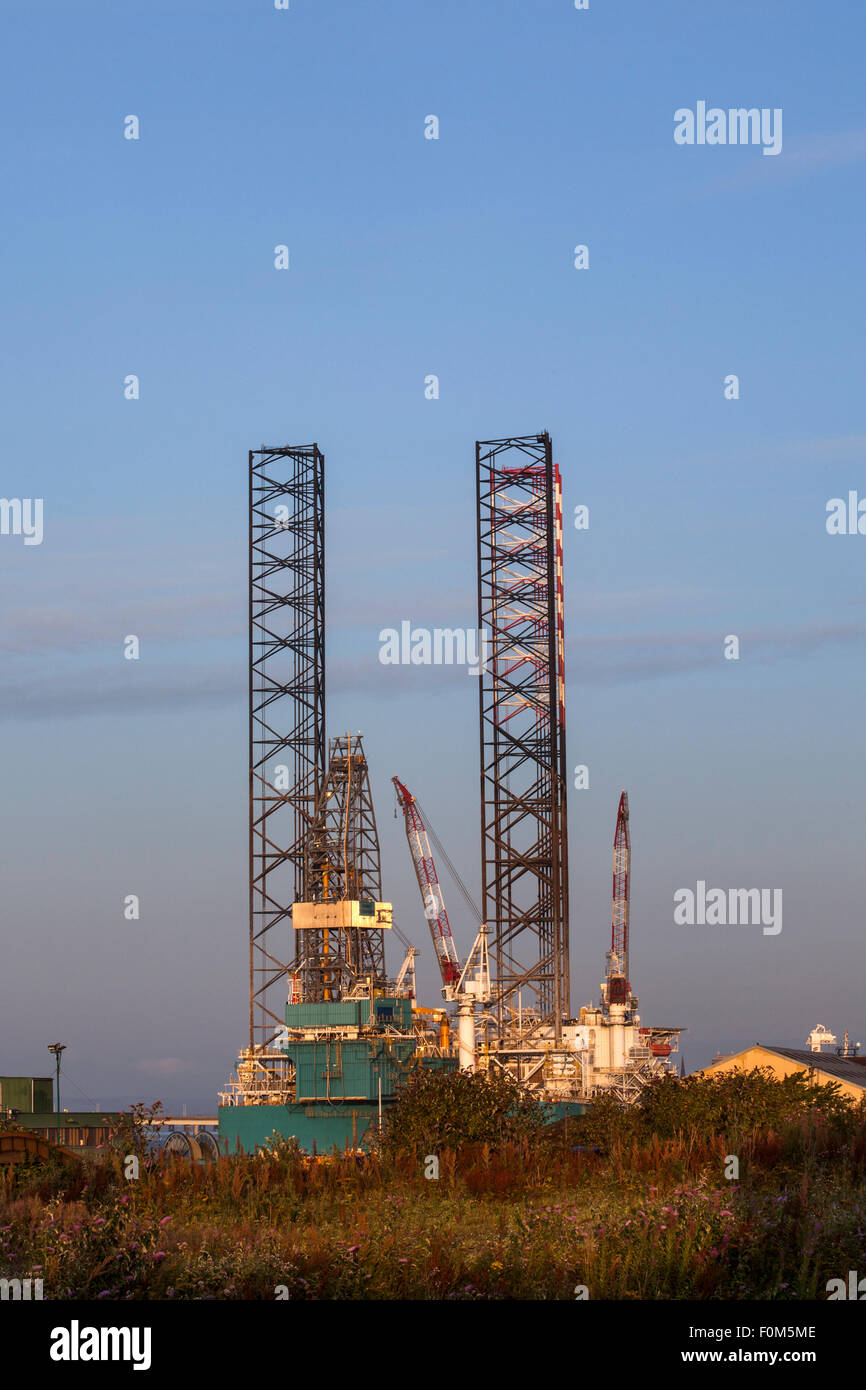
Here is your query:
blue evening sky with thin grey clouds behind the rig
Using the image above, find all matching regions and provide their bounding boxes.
[0,0,866,1105]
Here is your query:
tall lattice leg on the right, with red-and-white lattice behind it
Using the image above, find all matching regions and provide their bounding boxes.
[475,432,570,1045]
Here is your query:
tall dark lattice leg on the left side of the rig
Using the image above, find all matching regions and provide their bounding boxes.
[249,443,325,1049]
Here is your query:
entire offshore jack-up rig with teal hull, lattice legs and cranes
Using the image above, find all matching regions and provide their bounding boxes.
[218,432,681,1152]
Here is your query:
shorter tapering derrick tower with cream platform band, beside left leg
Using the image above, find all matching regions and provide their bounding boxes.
[297,734,385,1004]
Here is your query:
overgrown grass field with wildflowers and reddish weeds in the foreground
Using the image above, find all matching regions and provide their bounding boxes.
[0,1083,866,1300]
